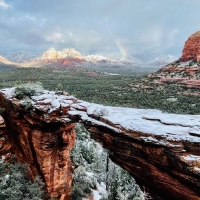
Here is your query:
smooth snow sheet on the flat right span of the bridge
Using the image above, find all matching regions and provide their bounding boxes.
[77,102,200,142]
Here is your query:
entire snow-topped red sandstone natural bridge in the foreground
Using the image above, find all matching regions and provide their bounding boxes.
[0,88,200,200]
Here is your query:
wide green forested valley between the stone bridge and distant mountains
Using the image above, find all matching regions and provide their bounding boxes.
[0,68,200,114]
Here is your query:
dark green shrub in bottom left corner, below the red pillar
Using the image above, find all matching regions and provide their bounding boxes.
[0,159,44,200]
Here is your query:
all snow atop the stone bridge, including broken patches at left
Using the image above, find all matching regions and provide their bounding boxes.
[1,88,200,144]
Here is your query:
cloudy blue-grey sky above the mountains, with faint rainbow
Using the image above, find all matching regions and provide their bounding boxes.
[0,0,200,57]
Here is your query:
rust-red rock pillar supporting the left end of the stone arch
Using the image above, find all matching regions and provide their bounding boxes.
[0,89,75,200]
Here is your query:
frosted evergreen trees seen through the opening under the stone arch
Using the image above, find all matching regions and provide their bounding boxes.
[71,124,148,200]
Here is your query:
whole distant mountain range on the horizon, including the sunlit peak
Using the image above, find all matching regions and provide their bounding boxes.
[1,47,178,74]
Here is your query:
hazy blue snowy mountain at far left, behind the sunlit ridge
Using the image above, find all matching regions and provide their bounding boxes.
[0,51,39,63]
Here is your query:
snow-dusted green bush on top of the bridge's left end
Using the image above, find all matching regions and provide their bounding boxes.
[13,83,44,99]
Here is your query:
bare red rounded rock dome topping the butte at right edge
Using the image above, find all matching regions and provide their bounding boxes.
[180,31,200,62]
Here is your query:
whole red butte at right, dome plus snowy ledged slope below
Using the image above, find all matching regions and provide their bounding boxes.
[149,31,200,88]
